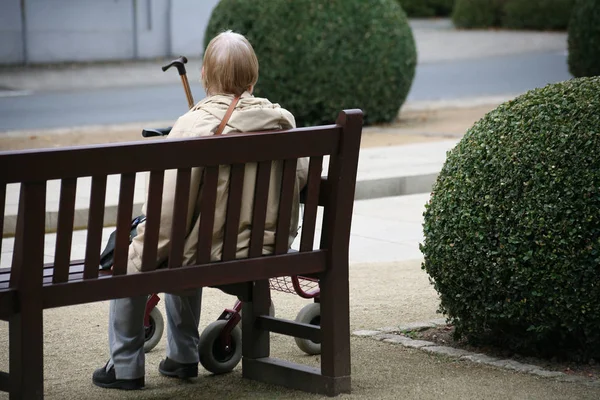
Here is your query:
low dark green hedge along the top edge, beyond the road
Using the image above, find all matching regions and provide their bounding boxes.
[453,0,575,30]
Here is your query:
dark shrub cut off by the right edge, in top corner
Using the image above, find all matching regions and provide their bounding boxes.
[569,0,600,77]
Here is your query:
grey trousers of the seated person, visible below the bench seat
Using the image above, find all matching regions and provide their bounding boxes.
[106,289,202,379]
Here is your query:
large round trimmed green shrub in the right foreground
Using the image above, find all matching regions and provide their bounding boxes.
[421,77,600,358]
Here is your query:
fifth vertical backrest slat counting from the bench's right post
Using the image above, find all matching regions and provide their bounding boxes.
[196,166,219,264]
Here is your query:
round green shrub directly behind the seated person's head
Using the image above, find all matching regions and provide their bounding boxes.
[206,0,417,126]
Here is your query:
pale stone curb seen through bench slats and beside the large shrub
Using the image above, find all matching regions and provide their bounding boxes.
[2,173,438,237]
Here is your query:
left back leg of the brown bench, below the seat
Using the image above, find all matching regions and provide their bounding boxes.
[9,307,44,400]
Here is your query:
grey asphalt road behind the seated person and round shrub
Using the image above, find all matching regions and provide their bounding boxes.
[0,53,571,134]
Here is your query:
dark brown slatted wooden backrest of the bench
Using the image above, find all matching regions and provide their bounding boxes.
[0,110,362,312]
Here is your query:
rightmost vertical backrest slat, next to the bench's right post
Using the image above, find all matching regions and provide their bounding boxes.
[300,157,323,251]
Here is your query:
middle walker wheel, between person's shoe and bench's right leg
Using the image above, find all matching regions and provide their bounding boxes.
[198,320,242,374]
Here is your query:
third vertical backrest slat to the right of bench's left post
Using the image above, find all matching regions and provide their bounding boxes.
[112,174,135,276]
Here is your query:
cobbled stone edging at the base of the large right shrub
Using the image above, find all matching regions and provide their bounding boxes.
[352,319,600,387]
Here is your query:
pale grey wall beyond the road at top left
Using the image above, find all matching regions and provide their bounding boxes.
[0,0,219,64]
